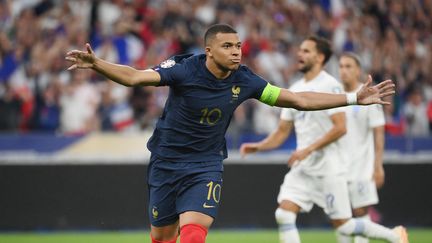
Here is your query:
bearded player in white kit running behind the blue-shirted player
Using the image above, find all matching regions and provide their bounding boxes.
[240,37,408,243]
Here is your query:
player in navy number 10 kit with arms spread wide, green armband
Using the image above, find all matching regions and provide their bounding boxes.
[66,24,394,243]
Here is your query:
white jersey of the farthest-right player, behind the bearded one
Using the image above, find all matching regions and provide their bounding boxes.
[341,84,385,181]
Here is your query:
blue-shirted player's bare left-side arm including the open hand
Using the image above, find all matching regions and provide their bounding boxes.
[65,43,160,86]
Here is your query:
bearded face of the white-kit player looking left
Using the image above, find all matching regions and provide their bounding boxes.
[297,40,322,73]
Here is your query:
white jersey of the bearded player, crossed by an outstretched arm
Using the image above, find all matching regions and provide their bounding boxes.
[280,71,345,176]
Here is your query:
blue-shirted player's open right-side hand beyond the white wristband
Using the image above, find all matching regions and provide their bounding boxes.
[357,75,395,105]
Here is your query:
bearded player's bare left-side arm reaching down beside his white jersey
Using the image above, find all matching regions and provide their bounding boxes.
[240,120,293,157]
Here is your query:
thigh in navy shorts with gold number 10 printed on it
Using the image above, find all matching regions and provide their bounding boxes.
[176,171,222,222]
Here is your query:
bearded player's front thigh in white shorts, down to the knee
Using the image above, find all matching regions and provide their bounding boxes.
[277,170,313,212]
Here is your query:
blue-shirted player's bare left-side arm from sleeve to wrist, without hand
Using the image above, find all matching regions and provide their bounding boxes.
[92,58,158,86]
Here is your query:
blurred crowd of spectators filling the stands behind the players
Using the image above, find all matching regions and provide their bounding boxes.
[0,0,432,136]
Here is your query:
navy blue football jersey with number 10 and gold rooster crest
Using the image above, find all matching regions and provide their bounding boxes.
[147,55,267,162]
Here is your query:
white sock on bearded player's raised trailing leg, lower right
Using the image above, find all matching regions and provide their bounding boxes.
[336,219,399,243]
